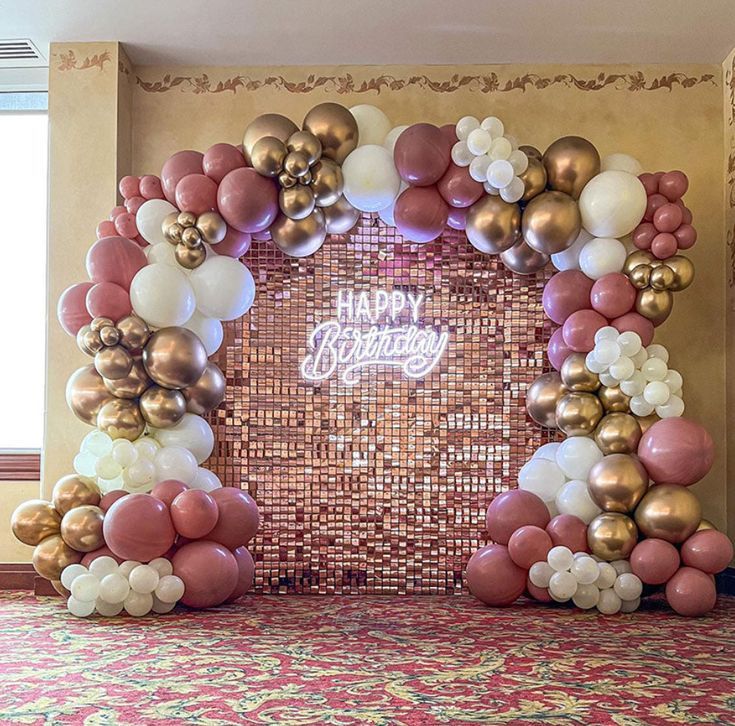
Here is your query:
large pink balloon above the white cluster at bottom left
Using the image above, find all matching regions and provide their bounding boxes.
[102,494,176,562]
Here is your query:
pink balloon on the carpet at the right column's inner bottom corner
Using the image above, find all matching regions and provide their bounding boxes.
[466,544,526,607]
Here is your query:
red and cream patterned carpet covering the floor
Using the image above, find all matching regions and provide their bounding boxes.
[0,593,735,726]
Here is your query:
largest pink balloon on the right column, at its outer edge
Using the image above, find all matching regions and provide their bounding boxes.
[638,417,715,487]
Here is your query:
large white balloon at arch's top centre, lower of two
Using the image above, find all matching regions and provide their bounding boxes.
[342,144,401,212]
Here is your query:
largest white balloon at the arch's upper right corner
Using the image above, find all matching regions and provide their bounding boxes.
[579,170,648,239]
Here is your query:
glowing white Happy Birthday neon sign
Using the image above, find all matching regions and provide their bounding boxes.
[301,290,449,386]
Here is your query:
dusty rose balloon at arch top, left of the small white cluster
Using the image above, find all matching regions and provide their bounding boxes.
[393,123,452,187]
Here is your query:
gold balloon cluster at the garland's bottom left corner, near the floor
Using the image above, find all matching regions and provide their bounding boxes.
[10,474,105,594]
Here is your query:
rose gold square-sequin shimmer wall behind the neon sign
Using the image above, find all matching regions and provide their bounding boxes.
[210,216,551,594]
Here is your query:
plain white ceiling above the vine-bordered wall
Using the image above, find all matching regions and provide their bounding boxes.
[0,0,735,65]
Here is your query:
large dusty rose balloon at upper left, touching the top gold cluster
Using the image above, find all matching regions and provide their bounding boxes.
[217,168,278,232]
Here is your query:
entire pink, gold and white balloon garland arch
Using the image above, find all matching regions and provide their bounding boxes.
[12,103,732,617]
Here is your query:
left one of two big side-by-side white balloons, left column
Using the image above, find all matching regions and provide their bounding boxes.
[130,262,196,328]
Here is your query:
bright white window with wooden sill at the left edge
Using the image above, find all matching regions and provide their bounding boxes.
[0,93,48,479]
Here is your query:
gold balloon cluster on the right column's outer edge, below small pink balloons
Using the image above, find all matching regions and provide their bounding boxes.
[623,250,694,325]
